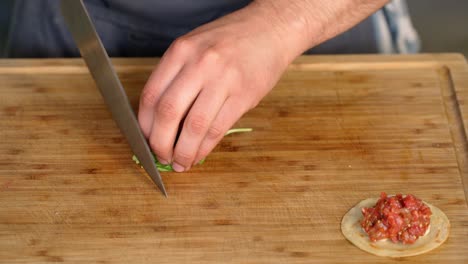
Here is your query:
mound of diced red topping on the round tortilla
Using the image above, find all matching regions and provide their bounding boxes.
[361,192,432,244]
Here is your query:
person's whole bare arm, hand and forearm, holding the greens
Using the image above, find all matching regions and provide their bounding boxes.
[138,0,386,172]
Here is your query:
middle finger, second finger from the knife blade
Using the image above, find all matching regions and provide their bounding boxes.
[149,65,203,164]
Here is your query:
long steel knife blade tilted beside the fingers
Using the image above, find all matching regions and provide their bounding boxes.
[60,0,167,197]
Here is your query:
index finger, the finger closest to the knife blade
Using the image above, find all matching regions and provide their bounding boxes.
[138,40,197,137]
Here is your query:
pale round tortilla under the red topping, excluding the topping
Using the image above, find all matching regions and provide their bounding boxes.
[341,198,450,258]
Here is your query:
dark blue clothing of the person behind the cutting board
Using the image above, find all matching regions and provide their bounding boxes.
[6,0,420,57]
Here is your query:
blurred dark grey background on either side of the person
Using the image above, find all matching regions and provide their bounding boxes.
[0,0,468,58]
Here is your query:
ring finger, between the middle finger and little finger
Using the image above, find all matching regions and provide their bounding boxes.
[172,88,227,172]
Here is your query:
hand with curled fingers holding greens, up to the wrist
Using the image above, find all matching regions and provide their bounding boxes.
[138,3,288,172]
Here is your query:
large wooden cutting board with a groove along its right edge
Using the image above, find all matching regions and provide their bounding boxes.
[0,54,468,263]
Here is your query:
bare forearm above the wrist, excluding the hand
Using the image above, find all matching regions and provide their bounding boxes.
[248,0,389,60]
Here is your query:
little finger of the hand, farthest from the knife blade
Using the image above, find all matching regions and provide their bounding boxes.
[194,97,249,164]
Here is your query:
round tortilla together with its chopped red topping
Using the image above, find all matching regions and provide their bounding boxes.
[341,193,450,257]
